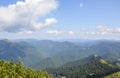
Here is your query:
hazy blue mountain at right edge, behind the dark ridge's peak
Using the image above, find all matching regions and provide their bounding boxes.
[89,41,120,55]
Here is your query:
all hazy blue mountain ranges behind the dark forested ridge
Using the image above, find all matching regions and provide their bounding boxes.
[0,39,120,68]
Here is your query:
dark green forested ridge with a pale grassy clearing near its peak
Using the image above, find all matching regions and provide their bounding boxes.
[47,56,120,78]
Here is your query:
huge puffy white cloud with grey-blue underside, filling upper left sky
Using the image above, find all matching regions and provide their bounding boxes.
[0,0,58,32]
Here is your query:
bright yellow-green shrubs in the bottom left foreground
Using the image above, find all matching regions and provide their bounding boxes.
[0,60,52,78]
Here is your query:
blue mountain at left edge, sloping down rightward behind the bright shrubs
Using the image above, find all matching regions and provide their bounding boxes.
[0,39,49,66]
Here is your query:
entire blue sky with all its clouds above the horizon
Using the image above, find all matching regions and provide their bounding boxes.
[0,0,120,39]
